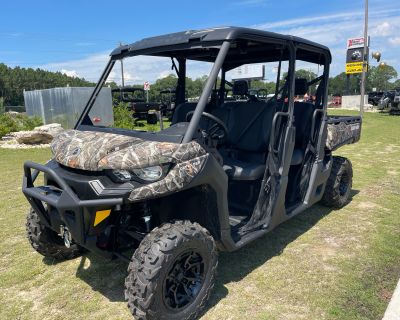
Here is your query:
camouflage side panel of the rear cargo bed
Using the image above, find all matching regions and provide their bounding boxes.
[326,122,361,150]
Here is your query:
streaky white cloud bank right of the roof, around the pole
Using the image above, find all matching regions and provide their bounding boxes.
[256,7,400,75]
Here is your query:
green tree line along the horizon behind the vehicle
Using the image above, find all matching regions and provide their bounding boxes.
[0,63,400,105]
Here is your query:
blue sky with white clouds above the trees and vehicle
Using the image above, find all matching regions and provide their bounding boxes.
[0,0,400,81]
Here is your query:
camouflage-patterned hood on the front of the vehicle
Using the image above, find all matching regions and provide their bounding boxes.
[51,130,206,171]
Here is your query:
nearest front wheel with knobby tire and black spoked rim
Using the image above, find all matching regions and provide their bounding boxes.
[125,221,218,320]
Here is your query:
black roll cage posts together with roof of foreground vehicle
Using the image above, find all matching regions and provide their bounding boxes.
[75,27,331,143]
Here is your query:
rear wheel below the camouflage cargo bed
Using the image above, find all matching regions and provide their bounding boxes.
[322,156,353,208]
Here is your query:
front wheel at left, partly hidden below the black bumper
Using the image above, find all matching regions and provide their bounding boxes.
[26,209,84,260]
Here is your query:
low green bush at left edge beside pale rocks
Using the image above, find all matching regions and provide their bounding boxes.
[0,113,43,138]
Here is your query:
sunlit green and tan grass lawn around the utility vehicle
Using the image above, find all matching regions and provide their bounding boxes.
[0,110,400,320]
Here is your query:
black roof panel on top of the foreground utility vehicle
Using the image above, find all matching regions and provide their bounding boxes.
[111,27,331,62]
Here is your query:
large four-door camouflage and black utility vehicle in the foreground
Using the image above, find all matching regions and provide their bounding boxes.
[22,27,361,319]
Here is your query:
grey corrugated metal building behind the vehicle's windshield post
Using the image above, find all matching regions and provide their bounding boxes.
[24,87,114,129]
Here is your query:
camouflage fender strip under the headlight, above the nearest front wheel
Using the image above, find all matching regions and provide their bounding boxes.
[129,154,209,201]
